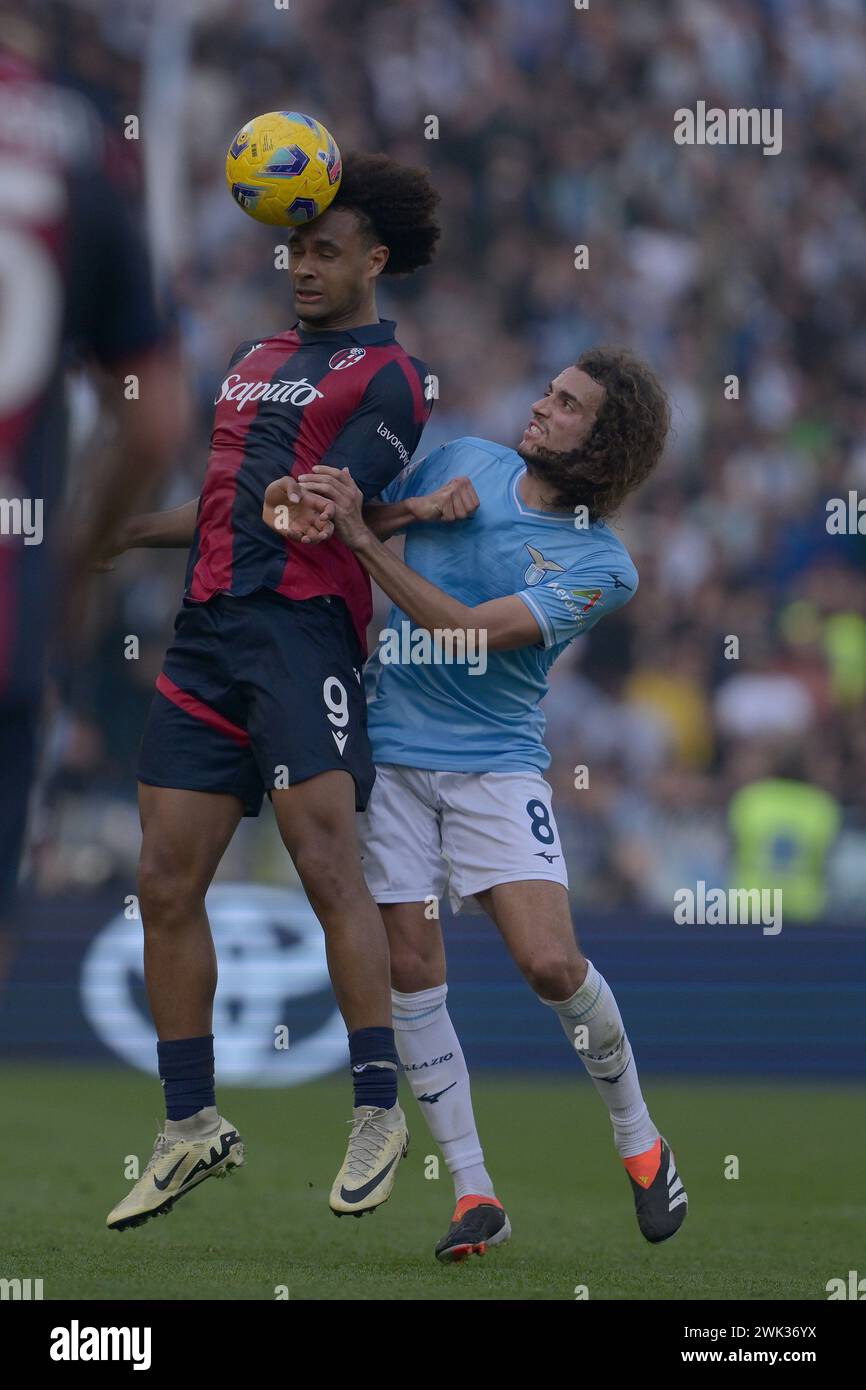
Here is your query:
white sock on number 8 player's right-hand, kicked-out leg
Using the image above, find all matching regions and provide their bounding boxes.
[539,960,659,1158]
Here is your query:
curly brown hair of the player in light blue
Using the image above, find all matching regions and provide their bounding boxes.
[539,348,670,521]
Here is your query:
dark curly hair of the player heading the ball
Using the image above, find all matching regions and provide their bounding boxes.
[331,153,441,275]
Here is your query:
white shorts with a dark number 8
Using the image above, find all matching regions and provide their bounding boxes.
[357,763,569,912]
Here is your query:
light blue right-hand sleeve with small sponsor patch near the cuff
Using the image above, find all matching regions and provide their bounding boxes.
[517,552,638,646]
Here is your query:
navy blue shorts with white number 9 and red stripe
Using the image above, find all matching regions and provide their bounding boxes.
[138,589,375,816]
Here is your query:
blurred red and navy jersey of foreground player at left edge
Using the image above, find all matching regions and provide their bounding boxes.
[0,49,163,701]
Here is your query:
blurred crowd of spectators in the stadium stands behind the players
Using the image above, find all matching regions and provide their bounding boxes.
[31,0,866,920]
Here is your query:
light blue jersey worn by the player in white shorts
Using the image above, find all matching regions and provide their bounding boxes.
[367,439,638,773]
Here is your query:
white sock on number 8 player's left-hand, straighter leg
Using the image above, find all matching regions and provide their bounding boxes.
[391,984,495,1201]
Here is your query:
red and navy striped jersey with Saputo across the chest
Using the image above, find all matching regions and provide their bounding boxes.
[186,320,431,649]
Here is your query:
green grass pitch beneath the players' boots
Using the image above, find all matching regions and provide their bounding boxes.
[0,1065,866,1301]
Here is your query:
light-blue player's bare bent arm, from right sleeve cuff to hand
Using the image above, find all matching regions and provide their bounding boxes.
[302,464,542,651]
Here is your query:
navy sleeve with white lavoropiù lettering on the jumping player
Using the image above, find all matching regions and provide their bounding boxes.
[321,359,430,499]
